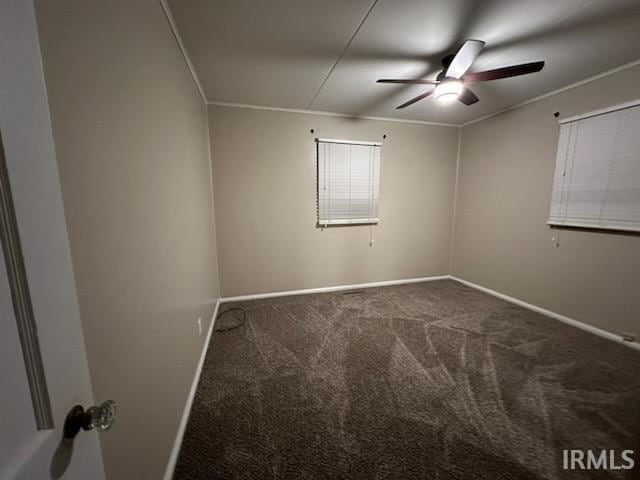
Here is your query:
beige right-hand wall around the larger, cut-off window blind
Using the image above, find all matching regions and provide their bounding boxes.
[453,62,640,333]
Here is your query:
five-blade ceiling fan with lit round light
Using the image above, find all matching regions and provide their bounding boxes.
[378,40,544,109]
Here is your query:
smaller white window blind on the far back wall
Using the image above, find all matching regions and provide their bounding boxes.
[317,138,381,225]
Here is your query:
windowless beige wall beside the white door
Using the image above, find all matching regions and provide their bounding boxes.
[36,0,218,480]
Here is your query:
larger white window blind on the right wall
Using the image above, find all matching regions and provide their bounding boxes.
[548,102,640,231]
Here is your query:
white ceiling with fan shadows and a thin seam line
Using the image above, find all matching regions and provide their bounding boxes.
[169,0,640,124]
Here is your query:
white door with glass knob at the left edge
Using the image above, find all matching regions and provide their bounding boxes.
[0,0,105,480]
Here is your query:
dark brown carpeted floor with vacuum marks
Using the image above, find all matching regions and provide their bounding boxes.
[174,280,640,480]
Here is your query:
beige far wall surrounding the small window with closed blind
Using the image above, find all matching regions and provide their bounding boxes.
[209,106,459,296]
